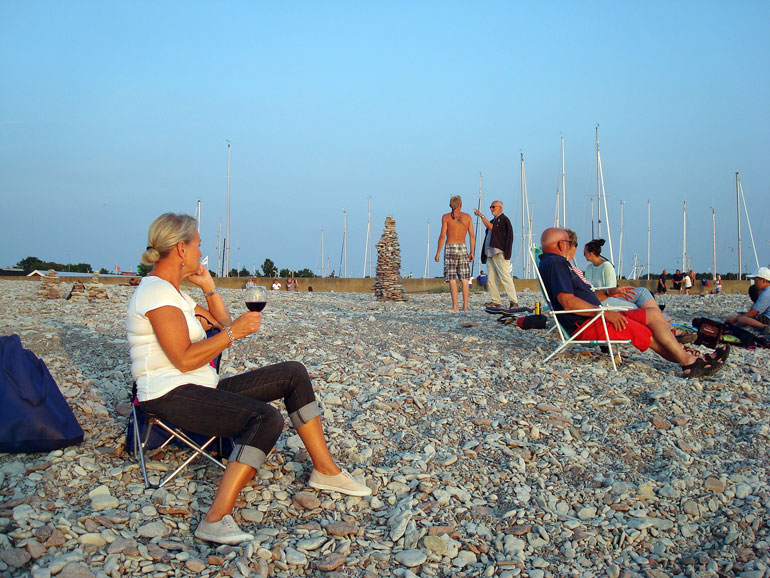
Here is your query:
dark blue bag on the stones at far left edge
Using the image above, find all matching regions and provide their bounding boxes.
[0,335,83,453]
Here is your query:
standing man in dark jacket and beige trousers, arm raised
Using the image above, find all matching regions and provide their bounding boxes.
[473,201,519,309]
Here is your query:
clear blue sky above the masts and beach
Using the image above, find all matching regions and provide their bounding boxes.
[0,1,770,277]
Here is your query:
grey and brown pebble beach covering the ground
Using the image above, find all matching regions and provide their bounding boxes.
[0,280,770,578]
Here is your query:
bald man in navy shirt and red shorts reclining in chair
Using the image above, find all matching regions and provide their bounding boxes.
[538,228,729,377]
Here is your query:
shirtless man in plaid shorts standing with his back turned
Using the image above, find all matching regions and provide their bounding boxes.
[436,195,476,311]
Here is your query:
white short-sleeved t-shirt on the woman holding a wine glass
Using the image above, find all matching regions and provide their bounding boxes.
[126,277,219,401]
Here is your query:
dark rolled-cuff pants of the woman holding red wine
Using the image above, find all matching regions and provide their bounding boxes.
[141,361,321,470]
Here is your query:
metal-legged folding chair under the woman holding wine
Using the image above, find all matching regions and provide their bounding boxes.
[129,329,225,489]
